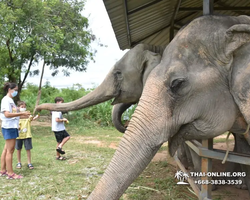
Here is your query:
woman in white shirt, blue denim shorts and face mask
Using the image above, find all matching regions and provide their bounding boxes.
[0,83,30,179]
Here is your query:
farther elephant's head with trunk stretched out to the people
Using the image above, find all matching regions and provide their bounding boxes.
[36,44,163,111]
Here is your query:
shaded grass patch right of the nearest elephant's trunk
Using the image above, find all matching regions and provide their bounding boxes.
[125,161,197,200]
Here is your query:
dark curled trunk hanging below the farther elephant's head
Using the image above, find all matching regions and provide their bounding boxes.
[112,103,132,133]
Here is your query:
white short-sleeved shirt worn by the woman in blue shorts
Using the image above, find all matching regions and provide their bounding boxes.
[0,96,20,129]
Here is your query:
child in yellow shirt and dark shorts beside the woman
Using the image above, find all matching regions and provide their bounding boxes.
[16,101,39,169]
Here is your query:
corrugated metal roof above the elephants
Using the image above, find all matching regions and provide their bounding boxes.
[103,0,250,50]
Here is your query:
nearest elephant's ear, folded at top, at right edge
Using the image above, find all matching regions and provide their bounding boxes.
[228,24,250,124]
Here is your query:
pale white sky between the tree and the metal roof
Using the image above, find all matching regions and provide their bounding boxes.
[27,0,126,88]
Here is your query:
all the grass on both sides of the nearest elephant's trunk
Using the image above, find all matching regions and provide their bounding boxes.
[0,121,196,200]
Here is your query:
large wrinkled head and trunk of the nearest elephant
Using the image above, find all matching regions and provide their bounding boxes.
[88,16,250,200]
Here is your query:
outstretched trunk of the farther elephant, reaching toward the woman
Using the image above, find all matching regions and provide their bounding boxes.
[36,72,119,112]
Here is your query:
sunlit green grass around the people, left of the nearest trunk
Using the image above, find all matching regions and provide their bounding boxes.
[0,126,120,199]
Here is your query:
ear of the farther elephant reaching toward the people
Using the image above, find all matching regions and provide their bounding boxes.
[138,50,161,85]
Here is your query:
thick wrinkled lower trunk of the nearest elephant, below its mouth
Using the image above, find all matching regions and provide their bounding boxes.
[88,102,162,200]
